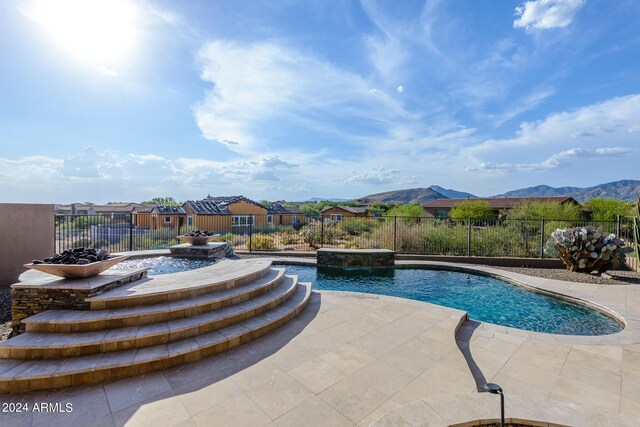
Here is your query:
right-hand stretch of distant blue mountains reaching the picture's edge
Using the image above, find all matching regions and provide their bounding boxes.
[494,179,640,202]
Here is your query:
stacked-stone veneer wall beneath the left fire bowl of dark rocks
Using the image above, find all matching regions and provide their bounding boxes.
[11,270,147,336]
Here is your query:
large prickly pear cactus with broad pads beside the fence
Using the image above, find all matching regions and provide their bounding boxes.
[544,225,633,273]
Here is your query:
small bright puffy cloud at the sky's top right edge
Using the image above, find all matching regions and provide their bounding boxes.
[513,0,585,30]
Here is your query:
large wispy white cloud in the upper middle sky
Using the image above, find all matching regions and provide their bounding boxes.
[194,41,410,154]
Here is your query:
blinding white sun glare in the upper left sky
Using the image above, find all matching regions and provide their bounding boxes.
[24,0,137,69]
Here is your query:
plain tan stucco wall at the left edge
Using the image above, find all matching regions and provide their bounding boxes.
[0,203,53,286]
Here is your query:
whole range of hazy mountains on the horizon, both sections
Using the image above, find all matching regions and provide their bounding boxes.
[355,179,640,204]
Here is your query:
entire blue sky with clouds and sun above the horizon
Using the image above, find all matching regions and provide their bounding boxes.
[0,0,640,203]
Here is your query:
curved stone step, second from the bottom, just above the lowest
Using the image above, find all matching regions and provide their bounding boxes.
[0,276,298,360]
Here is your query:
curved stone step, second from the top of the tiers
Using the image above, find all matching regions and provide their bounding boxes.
[22,268,284,333]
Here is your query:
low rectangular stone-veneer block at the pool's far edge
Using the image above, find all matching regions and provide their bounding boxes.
[317,248,396,268]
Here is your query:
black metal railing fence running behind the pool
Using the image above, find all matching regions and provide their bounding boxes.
[55,213,637,263]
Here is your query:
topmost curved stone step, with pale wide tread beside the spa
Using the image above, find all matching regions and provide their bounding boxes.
[86,259,271,310]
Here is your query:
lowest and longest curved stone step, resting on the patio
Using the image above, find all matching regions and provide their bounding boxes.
[0,283,311,393]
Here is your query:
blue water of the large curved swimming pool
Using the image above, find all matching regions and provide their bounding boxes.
[286,265,622,335]
